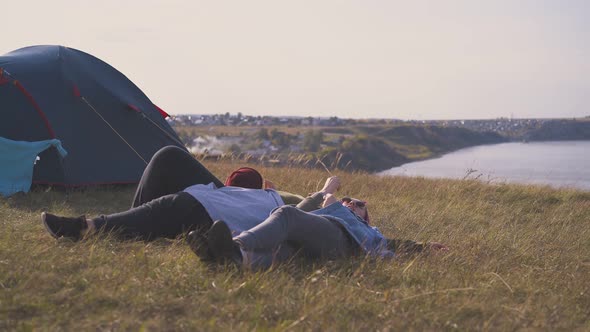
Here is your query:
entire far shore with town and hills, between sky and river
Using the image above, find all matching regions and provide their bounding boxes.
[175,117,590,173]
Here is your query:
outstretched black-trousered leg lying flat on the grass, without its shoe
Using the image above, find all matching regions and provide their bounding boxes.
[92,192,213,240]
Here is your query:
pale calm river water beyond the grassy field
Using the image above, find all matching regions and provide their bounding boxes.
[379,141,590,191]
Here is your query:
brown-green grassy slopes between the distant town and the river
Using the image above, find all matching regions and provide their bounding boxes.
[175,124,507,172]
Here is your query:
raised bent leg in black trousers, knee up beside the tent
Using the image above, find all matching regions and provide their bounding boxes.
[131,146,223,207]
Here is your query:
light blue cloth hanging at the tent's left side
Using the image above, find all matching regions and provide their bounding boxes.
[0,137,68,196]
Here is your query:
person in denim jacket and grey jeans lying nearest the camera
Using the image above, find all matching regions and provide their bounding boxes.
[188,177,448,268]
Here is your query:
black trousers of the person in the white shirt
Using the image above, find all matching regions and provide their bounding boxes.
[93,146,223,240]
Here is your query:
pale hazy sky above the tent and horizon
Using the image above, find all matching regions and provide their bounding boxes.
[0,0,590,120]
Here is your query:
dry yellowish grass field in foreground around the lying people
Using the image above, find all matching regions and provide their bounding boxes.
[0,163,590,331]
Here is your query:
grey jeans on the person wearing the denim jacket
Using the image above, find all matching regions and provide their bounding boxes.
[234,206,354,259]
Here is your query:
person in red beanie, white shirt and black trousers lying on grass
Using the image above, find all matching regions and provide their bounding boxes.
[42,146,303,246]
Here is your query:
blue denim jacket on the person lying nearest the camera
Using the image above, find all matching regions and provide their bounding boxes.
[310,202,394,257]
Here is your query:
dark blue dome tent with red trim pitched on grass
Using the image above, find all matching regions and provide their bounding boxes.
[0,46,184,191]
